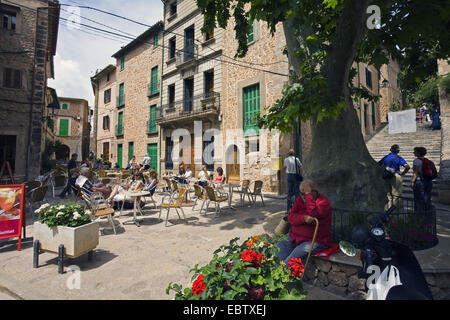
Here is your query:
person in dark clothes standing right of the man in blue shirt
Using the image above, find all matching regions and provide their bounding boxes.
[411,147,433,211]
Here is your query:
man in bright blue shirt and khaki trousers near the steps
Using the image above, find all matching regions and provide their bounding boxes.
[378,144,411,210]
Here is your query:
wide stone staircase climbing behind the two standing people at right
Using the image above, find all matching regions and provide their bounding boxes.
[366,122,441,202]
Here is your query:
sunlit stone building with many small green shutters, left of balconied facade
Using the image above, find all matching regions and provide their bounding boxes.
[91,22,163,170]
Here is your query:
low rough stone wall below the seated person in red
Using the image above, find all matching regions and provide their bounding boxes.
[303,254,450,300]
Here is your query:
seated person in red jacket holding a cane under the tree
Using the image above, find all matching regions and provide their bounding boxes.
[277,180,332,266]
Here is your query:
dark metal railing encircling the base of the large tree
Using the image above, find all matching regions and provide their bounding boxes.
[332,198,438,250]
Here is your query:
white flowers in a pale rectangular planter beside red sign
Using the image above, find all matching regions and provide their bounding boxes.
[33,202,99,257]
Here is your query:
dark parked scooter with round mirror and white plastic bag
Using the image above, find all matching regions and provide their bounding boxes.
[339,206,433,300]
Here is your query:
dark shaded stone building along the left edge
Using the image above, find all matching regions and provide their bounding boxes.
[0,0,59,182]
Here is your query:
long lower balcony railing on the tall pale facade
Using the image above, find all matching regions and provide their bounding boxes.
[156,92,220,122]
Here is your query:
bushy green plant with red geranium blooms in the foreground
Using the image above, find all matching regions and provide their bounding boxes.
[166,235,306,300]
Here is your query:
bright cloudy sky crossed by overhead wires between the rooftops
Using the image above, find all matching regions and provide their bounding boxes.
[48,0,163,108]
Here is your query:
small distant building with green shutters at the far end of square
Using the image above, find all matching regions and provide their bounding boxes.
[53,97,90,163]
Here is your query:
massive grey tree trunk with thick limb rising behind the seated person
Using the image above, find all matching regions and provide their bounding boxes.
[284,0,386,209]
